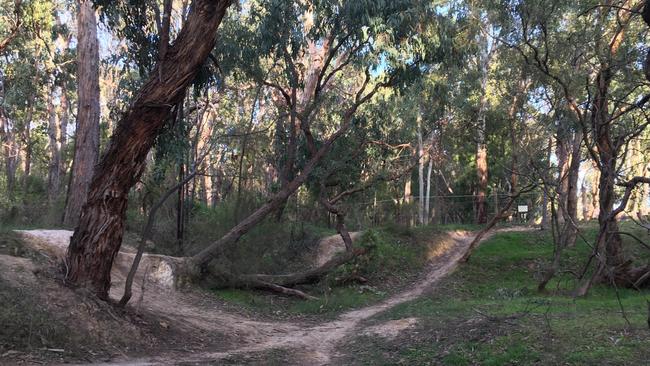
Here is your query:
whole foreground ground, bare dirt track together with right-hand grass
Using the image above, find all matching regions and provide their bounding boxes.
[0,224,650,365]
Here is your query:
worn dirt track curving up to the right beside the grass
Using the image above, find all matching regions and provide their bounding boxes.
[101,231,496,365]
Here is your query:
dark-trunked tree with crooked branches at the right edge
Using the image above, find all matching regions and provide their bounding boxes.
[502,0,650,295]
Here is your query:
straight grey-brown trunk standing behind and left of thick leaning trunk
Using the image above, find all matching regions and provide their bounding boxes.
[63,0,100,227]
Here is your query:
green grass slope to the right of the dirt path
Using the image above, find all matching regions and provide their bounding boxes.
[342,223,650,365]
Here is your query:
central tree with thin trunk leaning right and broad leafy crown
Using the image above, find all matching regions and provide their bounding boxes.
[185,0,440,278]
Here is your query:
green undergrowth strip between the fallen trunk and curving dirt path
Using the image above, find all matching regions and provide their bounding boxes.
[213,226,439,316]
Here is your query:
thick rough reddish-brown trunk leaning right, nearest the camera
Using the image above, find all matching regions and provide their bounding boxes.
[67,0,231,299]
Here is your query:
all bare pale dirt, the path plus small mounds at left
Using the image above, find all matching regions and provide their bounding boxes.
[0,230,528,365]
